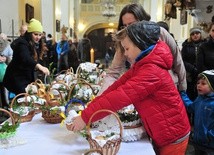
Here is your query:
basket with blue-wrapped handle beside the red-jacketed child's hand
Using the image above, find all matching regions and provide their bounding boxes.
[65,99,85,130]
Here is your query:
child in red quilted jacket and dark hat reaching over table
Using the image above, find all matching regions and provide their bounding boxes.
[71,21,190,155]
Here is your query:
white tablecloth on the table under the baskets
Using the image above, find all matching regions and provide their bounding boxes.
[0,114,155,155]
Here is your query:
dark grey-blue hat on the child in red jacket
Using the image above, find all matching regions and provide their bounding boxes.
[127,20,160,50]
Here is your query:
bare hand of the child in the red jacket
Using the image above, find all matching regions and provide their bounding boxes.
[71,116,86,132]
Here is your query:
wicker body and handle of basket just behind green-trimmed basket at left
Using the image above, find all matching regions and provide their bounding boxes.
[10,93,35,123]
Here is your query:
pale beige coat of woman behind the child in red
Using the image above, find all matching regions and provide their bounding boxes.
[99,27,187,95]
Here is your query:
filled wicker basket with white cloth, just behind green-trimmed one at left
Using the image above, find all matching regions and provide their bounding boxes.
[10,93,35,123]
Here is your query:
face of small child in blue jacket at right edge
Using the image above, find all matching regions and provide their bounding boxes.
[197,79,212,95]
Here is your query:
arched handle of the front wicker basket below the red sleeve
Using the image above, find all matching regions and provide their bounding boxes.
[86,109,123,138]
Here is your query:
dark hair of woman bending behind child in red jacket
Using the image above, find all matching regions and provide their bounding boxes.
[117,3,151,30]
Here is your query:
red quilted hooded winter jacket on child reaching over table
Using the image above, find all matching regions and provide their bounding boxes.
[82,41,190,147]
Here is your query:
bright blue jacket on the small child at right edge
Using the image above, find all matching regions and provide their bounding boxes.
[181,92,214,149]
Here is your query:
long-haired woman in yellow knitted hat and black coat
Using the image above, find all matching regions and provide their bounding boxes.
[3,19,50,95]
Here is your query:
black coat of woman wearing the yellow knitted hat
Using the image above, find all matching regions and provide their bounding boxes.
[3,37,37,94]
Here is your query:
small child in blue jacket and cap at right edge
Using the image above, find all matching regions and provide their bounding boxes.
[181,70,214,155]
